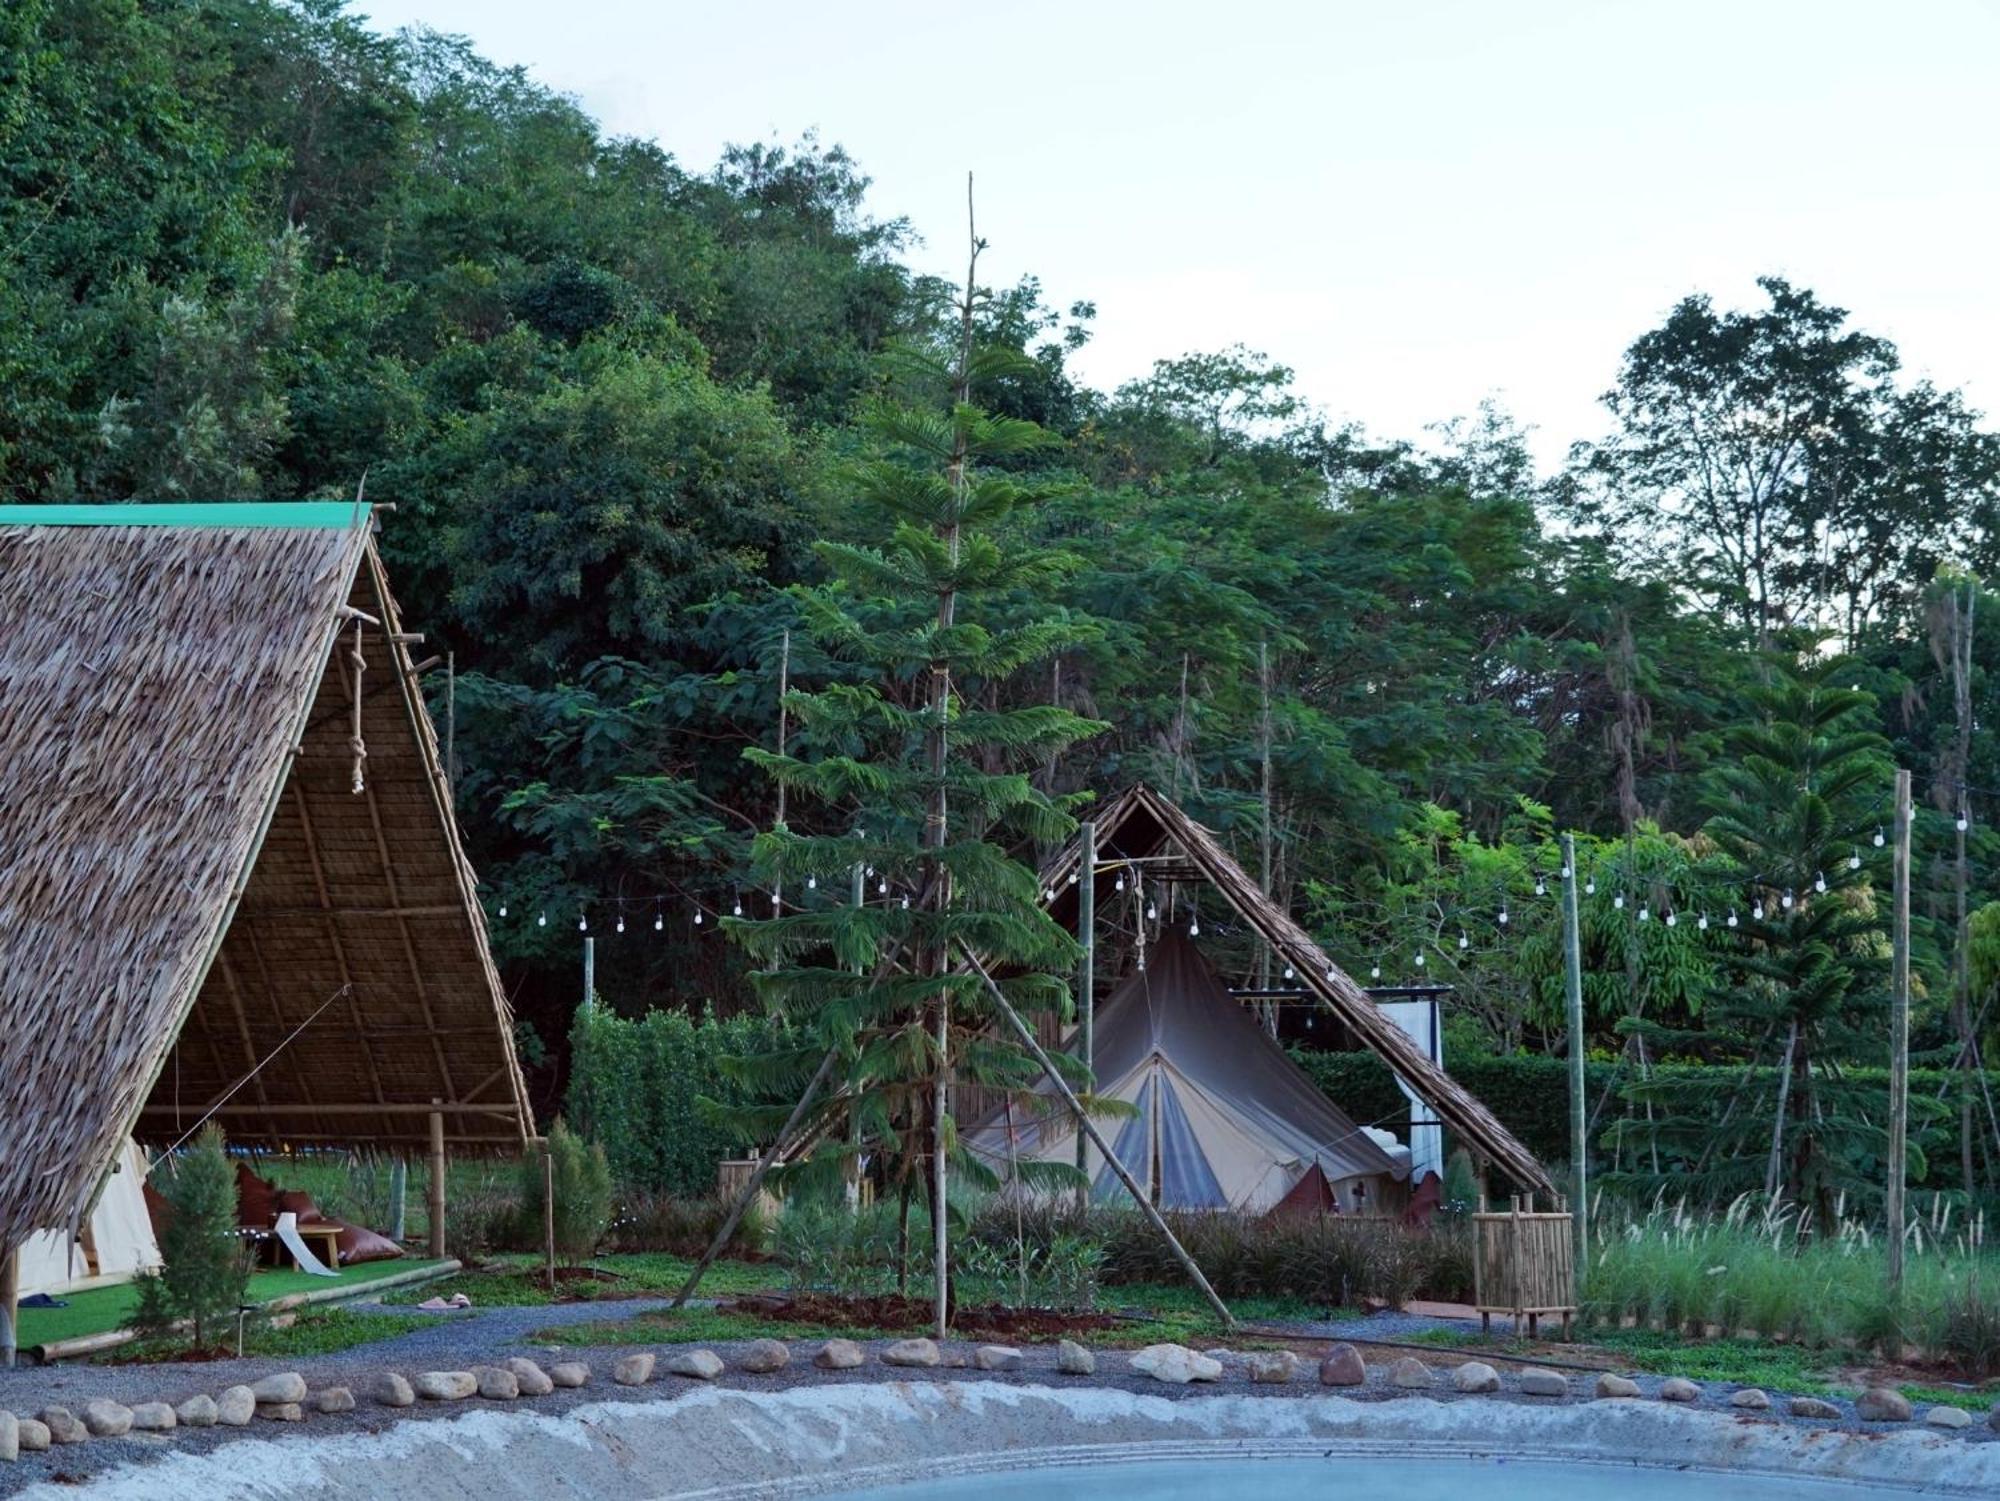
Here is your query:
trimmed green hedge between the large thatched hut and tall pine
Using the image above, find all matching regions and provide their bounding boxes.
[566,1005,776,1197]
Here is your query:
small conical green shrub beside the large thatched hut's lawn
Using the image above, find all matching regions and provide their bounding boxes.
[132,1125,250,1349]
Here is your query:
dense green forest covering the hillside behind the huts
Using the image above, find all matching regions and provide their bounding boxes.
[0,0,2000,1191]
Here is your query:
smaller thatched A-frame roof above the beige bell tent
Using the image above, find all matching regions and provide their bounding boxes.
[1042,787,1556,1195]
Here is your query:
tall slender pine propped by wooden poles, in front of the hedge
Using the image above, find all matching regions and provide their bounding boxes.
[732,191,1100,1335]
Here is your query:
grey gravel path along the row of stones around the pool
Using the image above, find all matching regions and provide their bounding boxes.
[0,1299,2000,1497]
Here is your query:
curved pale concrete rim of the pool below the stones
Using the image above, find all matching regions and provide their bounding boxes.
[20,1381,2000,1501]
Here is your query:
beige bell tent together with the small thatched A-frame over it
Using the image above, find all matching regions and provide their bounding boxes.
[964,787,1556,1213]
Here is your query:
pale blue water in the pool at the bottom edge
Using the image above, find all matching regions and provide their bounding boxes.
[832,1457,1912,1501]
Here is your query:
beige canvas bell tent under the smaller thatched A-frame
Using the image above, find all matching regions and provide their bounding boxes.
[968,933,1410,1215]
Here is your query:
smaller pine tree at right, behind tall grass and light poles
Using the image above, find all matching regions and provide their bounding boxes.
[1614,658,1896,1229]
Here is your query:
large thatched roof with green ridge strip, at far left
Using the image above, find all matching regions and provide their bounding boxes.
[0,504,532,1249]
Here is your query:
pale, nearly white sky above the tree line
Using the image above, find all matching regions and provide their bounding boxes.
[356,0,2000,460]
